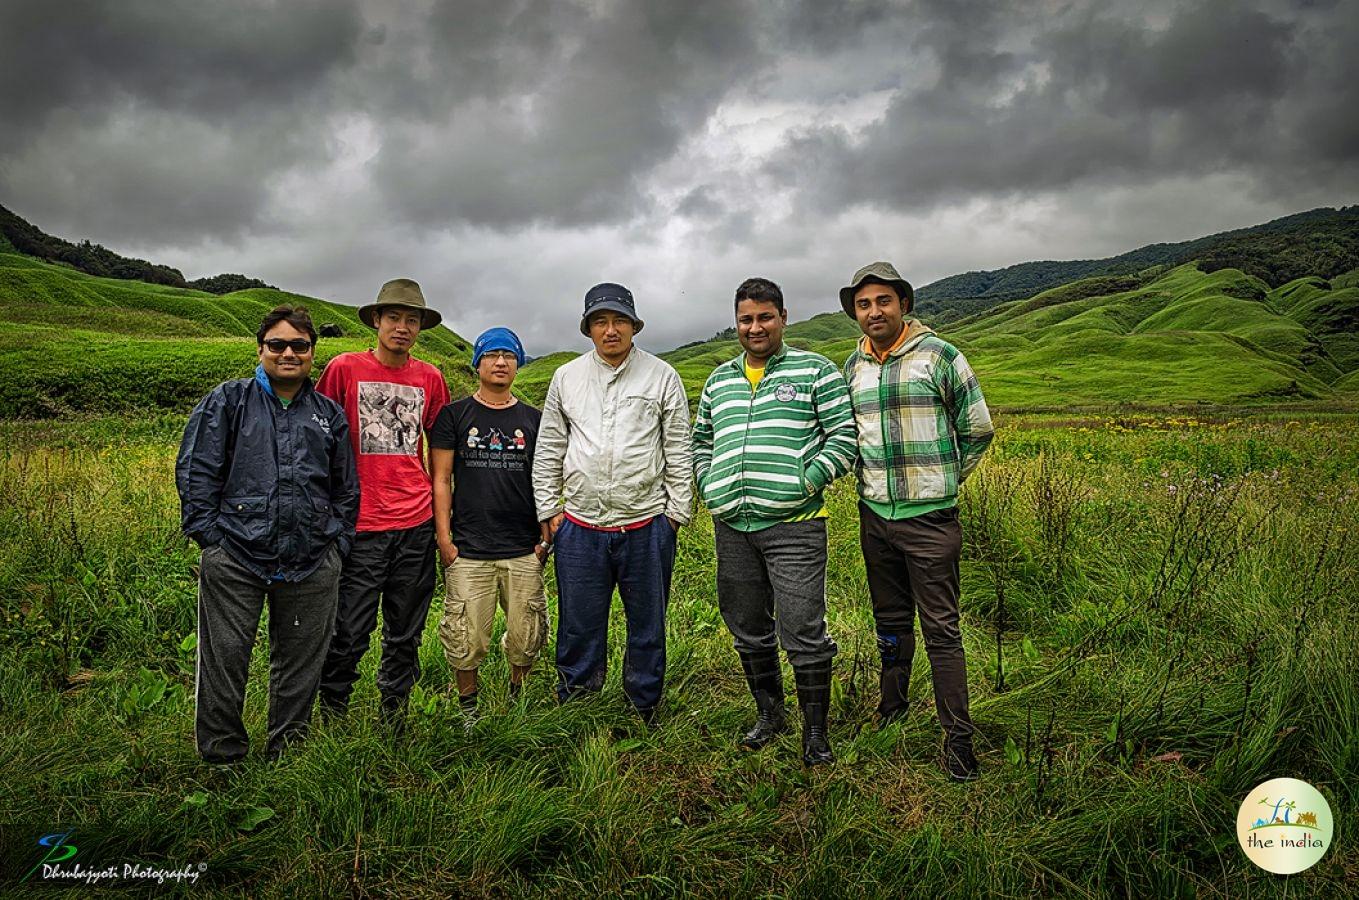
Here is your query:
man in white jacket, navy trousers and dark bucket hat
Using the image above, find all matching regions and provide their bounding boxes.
[533,283,693,722]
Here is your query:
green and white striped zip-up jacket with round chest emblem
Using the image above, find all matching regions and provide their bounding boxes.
[693,344,858,532]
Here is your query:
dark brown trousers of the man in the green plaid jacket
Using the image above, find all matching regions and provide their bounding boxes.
[859,502,973,742]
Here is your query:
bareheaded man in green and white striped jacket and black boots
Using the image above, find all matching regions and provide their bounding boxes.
[693,279,858,765]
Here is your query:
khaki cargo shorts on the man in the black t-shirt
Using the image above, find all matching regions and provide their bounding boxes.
[439,553,548,672]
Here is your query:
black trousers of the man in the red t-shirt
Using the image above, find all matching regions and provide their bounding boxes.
[321,519,435,712]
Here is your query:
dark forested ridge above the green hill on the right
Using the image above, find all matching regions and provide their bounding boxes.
[916,207,1359,322]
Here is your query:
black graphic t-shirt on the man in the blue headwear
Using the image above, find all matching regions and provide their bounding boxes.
[429,397,542,559]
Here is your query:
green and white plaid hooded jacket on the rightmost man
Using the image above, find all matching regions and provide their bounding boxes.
[844,319,995,510]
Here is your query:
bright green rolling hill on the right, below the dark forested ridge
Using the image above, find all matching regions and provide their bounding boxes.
[519,264,1359,409]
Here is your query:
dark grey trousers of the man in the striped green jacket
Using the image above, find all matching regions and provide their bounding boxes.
[712,519,837,668]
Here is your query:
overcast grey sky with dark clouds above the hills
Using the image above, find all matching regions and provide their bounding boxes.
[0,0,1359,355]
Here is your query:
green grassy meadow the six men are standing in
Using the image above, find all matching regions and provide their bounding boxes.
[0,413,1359,897]
